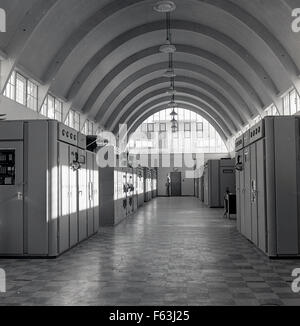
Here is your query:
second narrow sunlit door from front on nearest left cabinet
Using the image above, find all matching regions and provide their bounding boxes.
[69,146,78,247]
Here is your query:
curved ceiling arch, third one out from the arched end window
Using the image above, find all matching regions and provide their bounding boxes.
[106,76,246,129]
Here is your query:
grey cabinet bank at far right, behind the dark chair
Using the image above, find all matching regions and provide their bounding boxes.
[201,159,236,208]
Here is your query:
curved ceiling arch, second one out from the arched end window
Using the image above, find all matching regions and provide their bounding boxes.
[110,87,239,133]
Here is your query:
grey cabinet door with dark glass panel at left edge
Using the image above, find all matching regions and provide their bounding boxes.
[0,142,24,255]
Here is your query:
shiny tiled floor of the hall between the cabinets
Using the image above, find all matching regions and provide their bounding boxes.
[0,198,300,306]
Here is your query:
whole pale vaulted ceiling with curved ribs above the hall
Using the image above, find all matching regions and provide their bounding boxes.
[0,0,300,143]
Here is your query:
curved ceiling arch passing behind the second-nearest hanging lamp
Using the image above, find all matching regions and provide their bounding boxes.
[82,45,264,118]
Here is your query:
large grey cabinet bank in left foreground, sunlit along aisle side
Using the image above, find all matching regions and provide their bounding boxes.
[0,120,99,257]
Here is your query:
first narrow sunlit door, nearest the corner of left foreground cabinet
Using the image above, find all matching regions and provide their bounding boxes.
[58,143,70,254]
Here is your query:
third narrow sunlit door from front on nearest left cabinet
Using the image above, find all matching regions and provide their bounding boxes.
[78,150,88,241]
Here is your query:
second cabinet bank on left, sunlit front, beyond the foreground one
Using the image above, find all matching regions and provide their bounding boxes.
[99,167,138,226]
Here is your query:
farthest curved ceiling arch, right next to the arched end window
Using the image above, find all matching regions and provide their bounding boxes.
[111,94,236,136]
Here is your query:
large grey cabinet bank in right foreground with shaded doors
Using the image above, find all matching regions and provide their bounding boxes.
[236,117,300,257]
